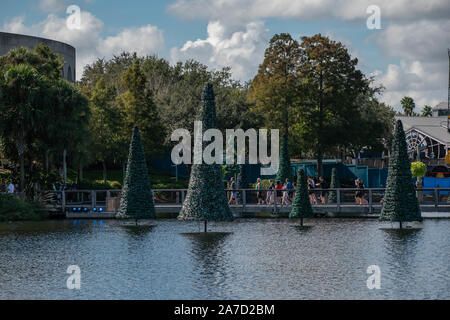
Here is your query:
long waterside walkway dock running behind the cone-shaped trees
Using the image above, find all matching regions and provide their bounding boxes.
[38,188,450,219]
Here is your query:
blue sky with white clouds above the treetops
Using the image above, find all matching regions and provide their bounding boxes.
[0,0,450,111]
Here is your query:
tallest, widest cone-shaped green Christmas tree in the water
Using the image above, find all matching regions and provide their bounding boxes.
[178,83,233,232]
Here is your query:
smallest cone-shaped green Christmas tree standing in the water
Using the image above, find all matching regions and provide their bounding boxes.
[289,168,314,226]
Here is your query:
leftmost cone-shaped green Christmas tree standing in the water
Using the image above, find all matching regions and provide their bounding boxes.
[116,127,155,221]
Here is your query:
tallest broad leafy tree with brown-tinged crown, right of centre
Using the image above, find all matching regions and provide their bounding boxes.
[249,34,394,175]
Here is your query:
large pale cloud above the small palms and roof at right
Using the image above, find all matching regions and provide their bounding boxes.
[375,19,450,111]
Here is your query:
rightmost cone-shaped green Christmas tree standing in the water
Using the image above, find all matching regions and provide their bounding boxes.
[380,120,422,228]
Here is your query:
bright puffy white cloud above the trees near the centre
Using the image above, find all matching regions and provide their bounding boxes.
[171,21,268,80]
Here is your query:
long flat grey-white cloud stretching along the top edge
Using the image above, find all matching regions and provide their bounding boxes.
[168,0,450,21]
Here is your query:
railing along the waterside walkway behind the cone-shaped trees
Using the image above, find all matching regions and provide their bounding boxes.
[37,188,450,213]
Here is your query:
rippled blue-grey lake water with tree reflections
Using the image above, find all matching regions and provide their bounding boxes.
[0,219,450,299]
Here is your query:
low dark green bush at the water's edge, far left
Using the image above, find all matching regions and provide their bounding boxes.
[0,194,48,222]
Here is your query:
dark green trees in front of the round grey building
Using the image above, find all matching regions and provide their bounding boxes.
[0,45,90,194]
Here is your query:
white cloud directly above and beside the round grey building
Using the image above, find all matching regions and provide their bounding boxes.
[1,11,164,79]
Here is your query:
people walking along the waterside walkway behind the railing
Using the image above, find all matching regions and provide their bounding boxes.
[228,177,367,205]
